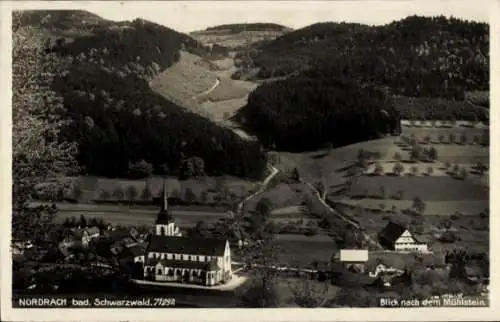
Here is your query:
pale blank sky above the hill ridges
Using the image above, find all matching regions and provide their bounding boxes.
[9,0,495,32]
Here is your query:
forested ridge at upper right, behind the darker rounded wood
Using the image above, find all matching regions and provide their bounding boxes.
[242,16,489,99]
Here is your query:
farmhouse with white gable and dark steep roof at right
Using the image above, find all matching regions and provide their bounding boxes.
[378,222,427,252]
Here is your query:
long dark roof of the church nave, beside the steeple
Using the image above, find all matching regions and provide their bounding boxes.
[148,235,226,256]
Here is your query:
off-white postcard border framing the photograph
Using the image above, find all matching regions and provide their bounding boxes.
[0,0,500,321]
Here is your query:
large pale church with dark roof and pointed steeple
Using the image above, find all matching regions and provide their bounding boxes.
[134,180,232,286]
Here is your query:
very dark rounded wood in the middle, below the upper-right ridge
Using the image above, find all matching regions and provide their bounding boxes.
[237,69,399,151]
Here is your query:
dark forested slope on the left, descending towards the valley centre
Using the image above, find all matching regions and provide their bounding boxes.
[14,11,265,177]
